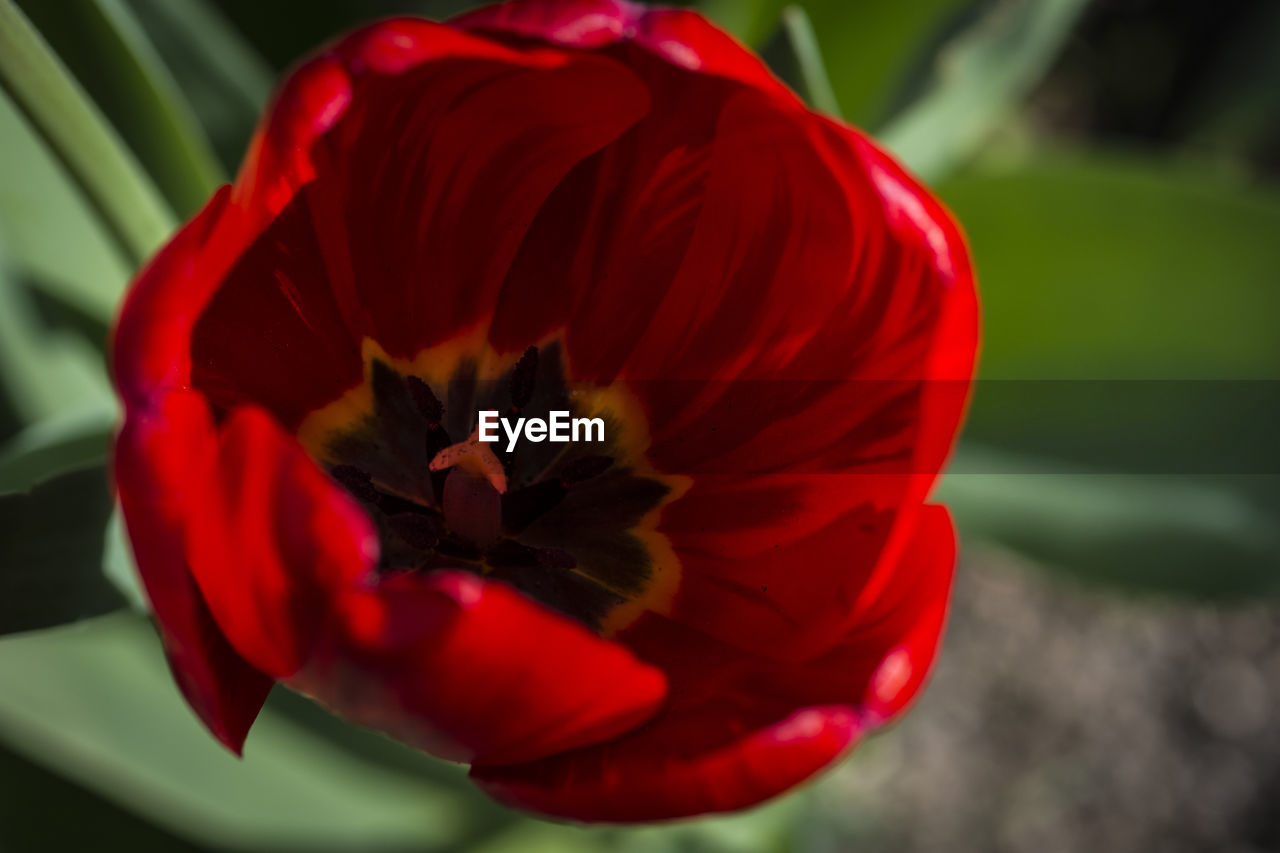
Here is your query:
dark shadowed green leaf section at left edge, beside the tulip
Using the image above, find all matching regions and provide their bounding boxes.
[0,466,124,634]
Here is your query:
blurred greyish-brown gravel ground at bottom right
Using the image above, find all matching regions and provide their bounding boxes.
[803,551,1280,853]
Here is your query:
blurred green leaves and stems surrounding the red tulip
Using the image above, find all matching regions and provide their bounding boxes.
[0,0,1280,853]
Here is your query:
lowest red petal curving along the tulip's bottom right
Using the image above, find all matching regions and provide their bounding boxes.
[472,507,955,821]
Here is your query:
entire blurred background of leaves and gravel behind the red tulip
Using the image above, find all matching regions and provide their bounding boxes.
[0,0,1280,853]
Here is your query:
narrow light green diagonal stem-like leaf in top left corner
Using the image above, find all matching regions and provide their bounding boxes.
[0,0,174,265]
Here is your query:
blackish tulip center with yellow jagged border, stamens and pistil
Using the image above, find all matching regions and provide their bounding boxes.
[300,342,680,633]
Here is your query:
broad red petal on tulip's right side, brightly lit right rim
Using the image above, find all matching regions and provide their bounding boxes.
[522,95,977,658]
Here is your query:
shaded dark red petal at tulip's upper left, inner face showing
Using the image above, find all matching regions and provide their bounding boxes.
[192,32,648,428]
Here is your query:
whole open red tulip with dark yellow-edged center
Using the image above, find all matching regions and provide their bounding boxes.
[114,0,977,820]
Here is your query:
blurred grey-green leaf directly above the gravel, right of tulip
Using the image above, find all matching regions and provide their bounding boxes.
[937,446,1280,599]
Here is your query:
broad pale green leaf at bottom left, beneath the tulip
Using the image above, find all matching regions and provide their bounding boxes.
[0,613,485,850]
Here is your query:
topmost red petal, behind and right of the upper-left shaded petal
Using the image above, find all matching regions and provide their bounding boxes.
[471,0,829,361]
